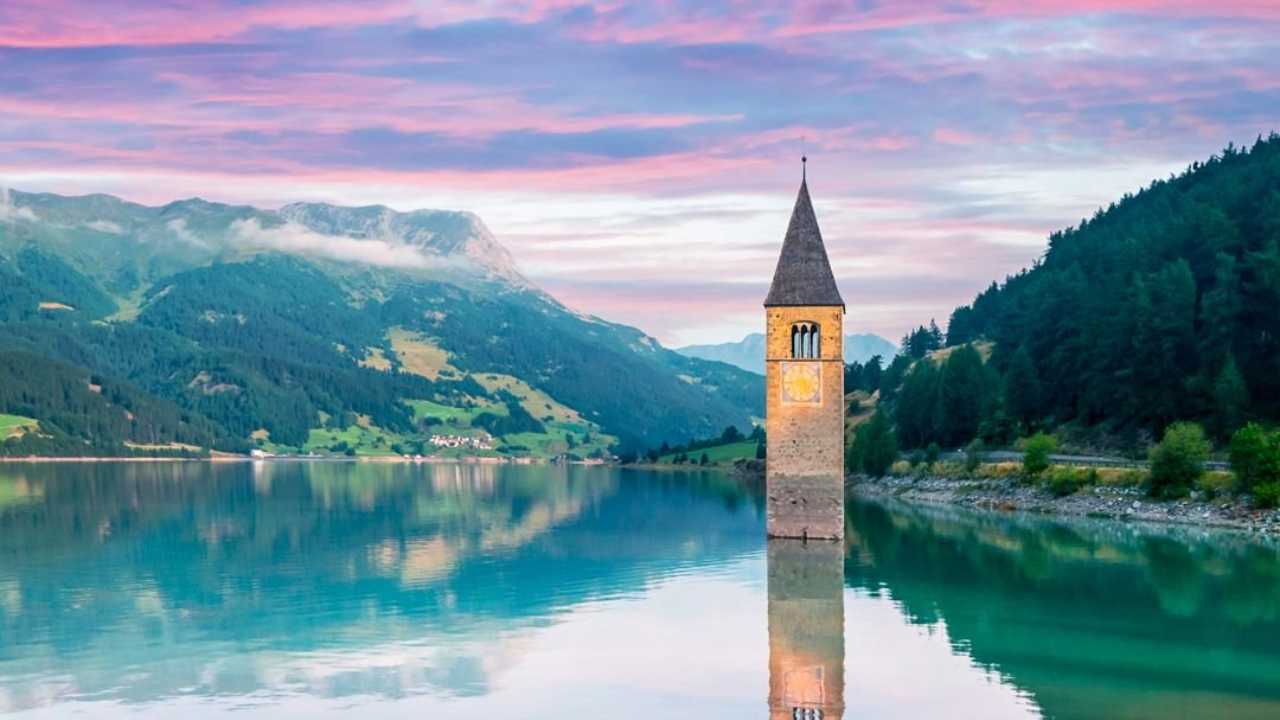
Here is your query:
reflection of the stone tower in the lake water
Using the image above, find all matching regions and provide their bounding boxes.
[768,538,845,720]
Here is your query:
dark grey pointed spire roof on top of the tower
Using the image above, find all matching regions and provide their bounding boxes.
[764,178,845,307]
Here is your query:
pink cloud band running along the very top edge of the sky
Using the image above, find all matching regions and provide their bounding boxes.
[10,0,1280,50]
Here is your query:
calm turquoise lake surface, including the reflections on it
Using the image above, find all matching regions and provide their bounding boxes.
[0,462,1280,719]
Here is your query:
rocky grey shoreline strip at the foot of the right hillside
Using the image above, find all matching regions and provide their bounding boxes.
[845,475,1280,536]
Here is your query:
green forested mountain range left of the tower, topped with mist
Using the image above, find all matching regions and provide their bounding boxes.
[0,185,763,456]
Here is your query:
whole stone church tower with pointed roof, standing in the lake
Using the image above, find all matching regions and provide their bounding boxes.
[764,158,845,539]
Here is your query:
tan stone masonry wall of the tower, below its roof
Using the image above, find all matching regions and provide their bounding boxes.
[765,307,845,538]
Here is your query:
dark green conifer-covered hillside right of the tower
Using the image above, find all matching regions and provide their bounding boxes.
[860,135,1280,447]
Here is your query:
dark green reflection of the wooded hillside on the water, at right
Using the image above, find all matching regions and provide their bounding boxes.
[845,501,1280,719]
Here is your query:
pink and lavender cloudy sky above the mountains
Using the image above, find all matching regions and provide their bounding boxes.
[0,0,1280,345]
